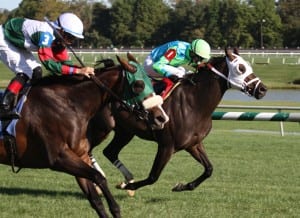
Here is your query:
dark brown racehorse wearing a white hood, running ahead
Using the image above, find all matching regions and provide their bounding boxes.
[86,49,267,194]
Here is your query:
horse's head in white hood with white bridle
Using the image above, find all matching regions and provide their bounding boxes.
[225,48,267,99]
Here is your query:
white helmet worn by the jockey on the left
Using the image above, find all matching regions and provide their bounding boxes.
[53,13,84,39]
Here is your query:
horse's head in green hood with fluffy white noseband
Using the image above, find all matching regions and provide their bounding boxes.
[117,53,169,129]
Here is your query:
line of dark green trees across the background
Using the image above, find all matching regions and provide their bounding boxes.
[0,0,300,49]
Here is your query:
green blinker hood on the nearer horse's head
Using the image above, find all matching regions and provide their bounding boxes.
[123,61,154,105]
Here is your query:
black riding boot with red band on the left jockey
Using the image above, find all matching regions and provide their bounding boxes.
[0,73,28,120]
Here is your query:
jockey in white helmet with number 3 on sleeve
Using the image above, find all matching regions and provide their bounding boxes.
[0,13,94,120]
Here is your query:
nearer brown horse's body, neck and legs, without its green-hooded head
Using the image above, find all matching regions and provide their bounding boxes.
[0,55,169,217]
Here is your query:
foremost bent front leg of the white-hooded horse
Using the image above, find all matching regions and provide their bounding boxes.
[172,142,213,191]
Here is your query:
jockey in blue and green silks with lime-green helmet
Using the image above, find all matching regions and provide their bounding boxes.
[144,39,211,96]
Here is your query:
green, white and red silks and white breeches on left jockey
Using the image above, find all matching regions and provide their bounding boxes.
[0,15,80,78]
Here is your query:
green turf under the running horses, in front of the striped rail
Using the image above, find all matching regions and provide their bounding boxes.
[0,127,300,218]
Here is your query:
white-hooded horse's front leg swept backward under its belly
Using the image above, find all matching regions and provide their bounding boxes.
[125,142,173,190]
